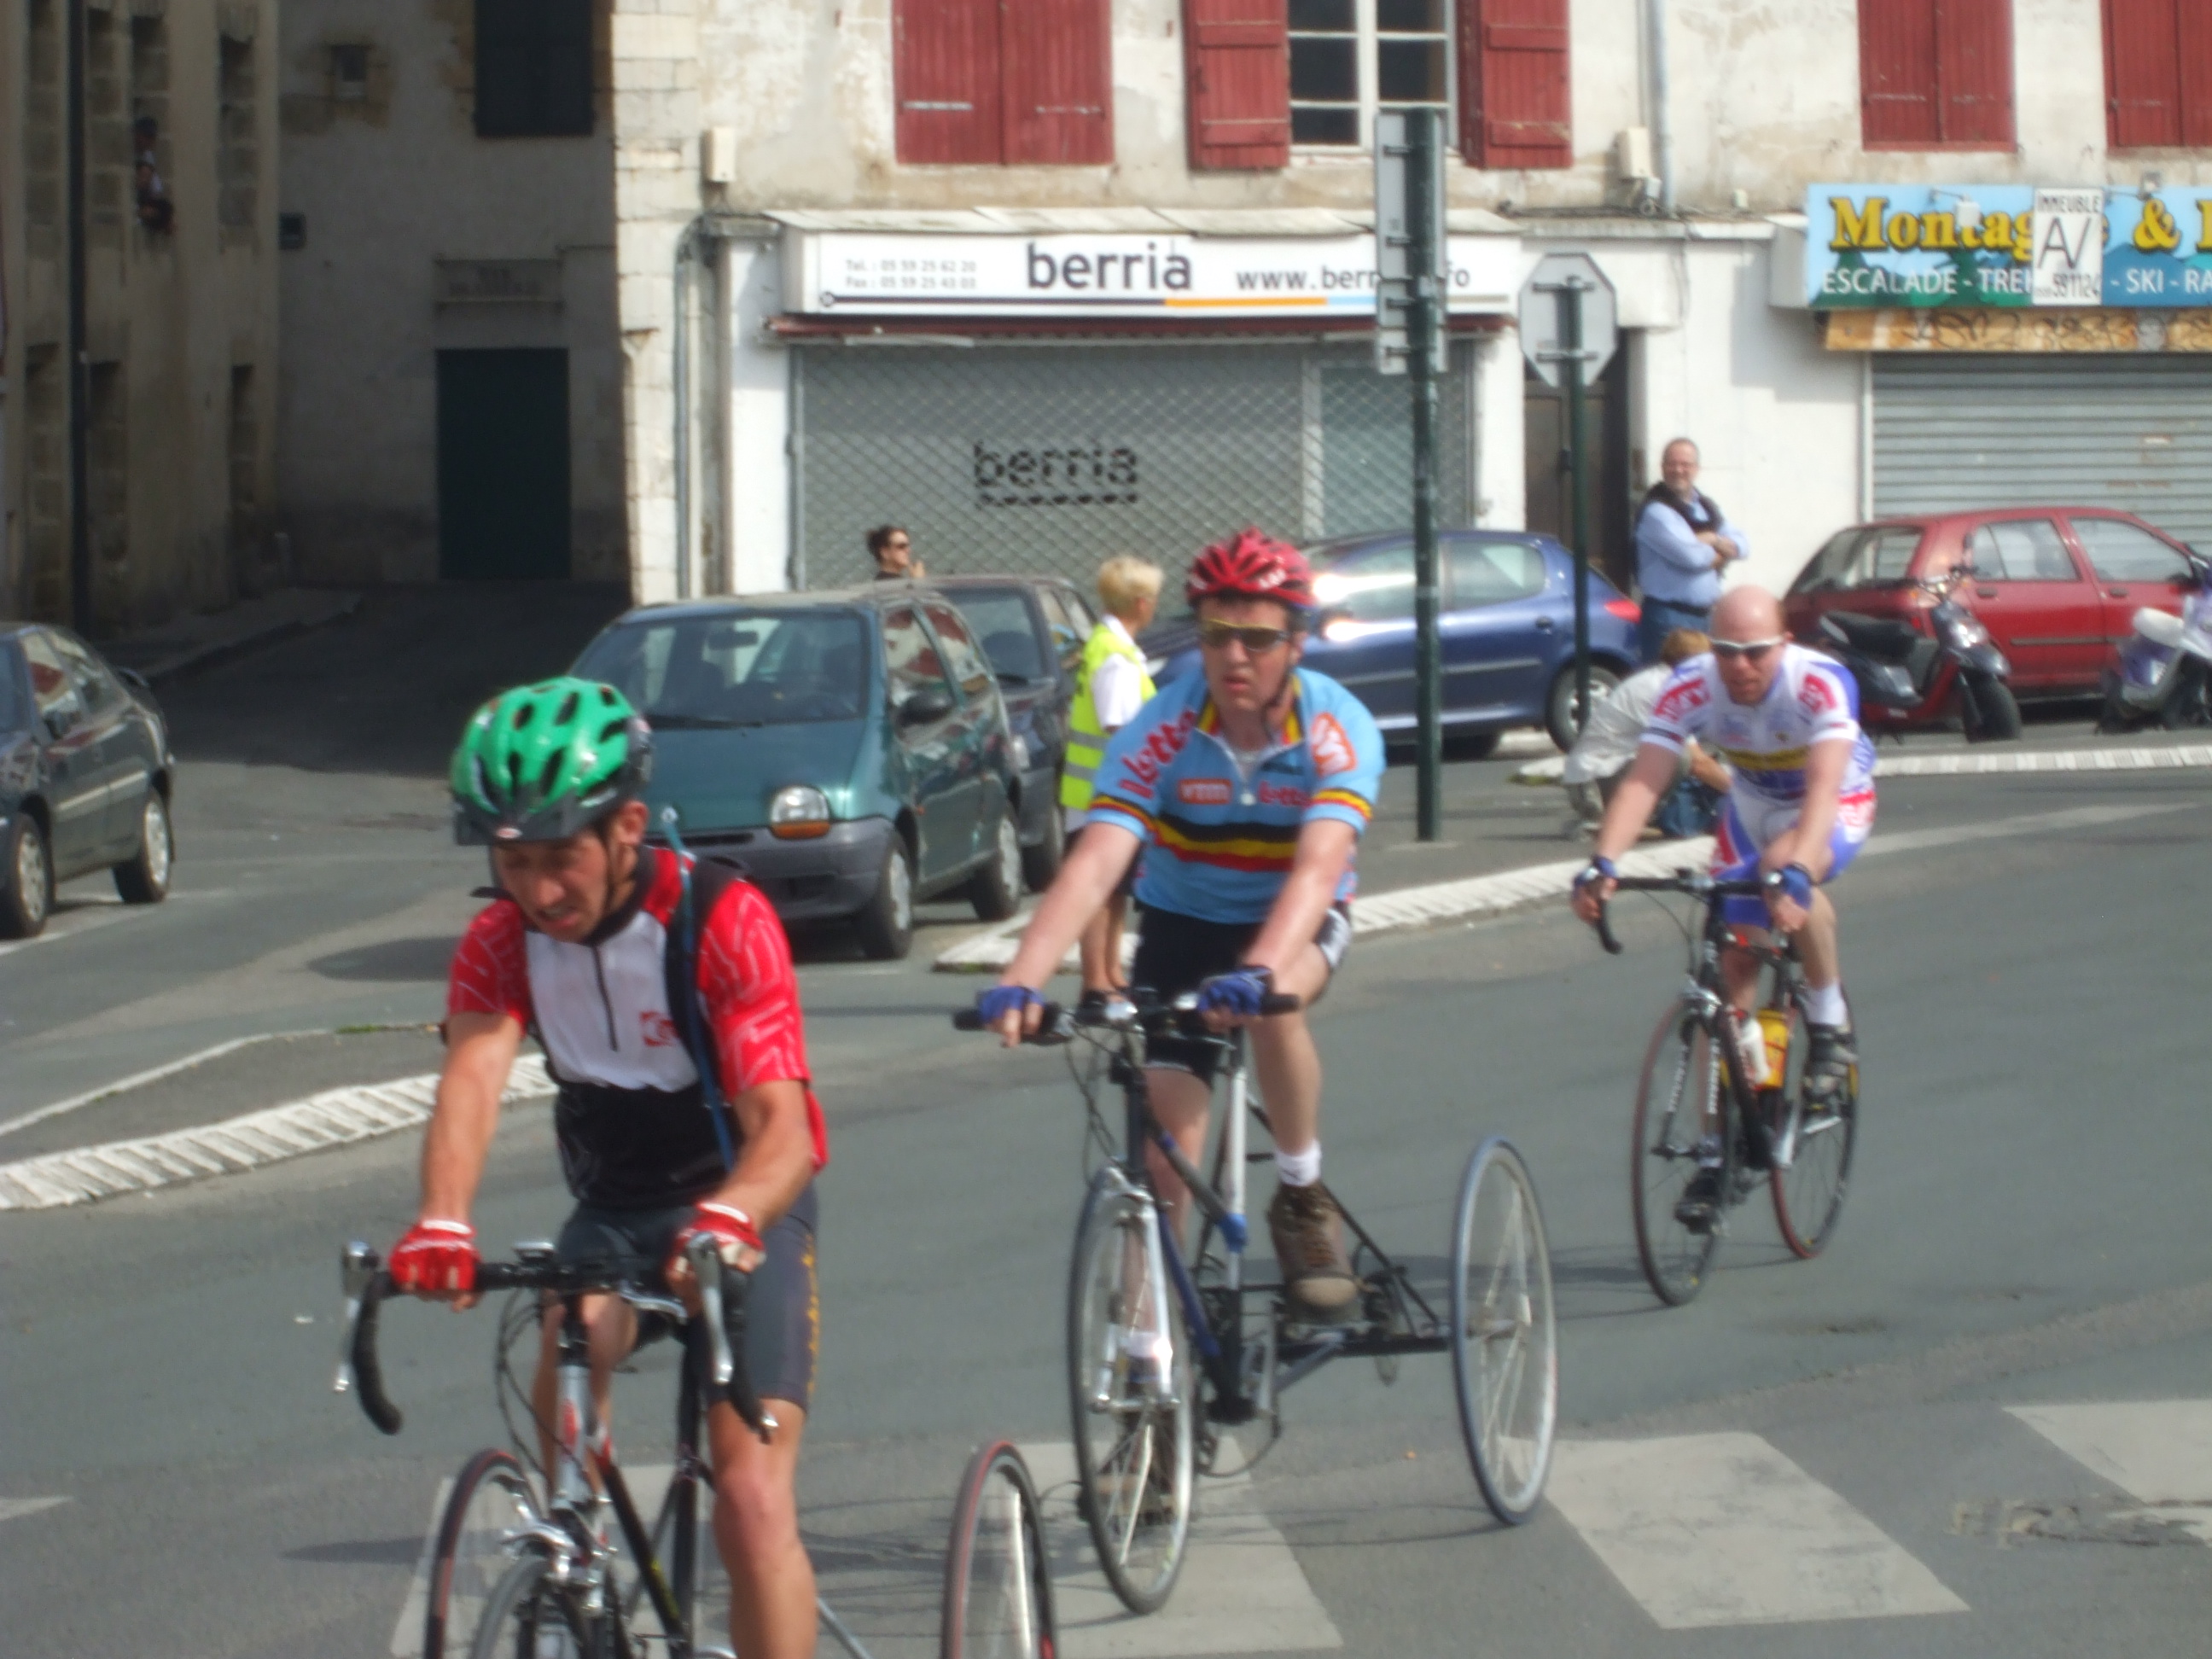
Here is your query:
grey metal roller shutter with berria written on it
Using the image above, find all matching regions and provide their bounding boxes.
[796,341,1473,588]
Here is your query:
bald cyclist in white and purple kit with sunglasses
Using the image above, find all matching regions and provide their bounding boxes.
[1575,586,1873,1206]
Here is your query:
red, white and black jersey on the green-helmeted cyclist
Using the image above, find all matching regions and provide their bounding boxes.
[447,847,830,1208]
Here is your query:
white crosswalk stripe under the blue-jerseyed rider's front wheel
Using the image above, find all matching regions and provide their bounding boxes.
[1022,1440,1345,1659]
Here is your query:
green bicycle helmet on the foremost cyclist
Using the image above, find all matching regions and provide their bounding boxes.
[451,677,653,847]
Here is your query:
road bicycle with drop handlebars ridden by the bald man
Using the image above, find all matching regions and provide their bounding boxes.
[1595,870,1858,1307]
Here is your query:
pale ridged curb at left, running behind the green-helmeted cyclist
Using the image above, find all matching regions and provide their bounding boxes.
[0,1055,553,1210]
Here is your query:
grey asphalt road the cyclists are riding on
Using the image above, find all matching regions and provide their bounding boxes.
[0,748,2212,1659]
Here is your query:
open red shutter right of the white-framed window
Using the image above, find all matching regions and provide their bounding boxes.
[1460,0,1575,168]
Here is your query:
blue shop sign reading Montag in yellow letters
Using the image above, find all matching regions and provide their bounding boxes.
[1805,183,2212,310]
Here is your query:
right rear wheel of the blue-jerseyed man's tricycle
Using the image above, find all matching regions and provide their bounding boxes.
[1451,1135,1559,1526]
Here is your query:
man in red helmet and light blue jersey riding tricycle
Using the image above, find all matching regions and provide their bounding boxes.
[975,528,1382,1320]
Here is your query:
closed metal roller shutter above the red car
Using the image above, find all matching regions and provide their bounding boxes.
[1873,354,2212,549]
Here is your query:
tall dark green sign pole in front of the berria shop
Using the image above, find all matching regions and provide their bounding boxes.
[1407,111,1445,841]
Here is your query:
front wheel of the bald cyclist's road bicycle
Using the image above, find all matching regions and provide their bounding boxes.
[1628,1002,1737,1307]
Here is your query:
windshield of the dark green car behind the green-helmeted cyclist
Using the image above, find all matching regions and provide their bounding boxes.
[575,610,867,730]
